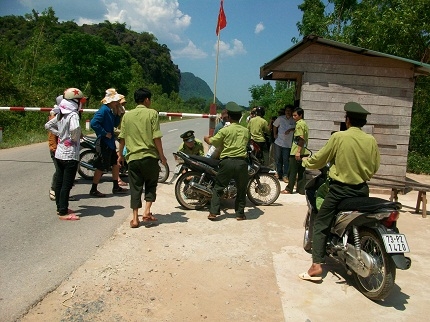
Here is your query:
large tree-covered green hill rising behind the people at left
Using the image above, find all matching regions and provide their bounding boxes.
[0,8,217,148]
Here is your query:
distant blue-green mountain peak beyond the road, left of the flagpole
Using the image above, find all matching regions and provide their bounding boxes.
[179,72,223,106]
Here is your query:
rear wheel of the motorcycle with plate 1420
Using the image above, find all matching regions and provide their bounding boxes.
[353,230,396,301]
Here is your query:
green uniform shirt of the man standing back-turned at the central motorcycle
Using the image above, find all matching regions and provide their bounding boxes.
[210,123,250,159]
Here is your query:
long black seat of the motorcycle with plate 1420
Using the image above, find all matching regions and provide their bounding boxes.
[337,197,402,212]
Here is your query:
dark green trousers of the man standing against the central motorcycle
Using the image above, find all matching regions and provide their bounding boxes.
[209,158,248,217]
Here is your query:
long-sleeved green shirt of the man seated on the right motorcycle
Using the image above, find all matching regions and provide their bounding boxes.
[302,127,380,185]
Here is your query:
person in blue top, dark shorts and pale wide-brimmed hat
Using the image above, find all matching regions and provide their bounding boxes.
[90,88,127,198]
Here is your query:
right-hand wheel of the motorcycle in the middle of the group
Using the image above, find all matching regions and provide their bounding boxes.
[247,173,281,206]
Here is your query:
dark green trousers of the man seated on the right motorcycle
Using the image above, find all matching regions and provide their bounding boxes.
[312,181,369,264]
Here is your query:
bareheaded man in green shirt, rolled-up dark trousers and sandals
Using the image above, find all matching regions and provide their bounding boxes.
[118,88,167,228]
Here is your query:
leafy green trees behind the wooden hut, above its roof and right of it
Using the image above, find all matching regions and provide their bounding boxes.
[297,0,430,173]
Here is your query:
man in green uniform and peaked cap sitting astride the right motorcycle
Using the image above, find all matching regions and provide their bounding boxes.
[299,102,380,281]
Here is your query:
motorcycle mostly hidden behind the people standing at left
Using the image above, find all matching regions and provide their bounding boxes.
[78,136,170,183]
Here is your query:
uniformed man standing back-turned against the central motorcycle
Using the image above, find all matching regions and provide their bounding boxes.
[204,102,250,220]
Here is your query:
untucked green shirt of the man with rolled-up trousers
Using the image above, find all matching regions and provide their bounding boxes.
[118,105,163,162]
